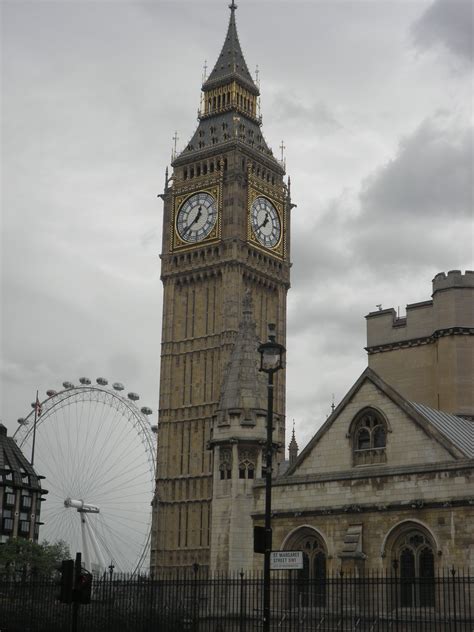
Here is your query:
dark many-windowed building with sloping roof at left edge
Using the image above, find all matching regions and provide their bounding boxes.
[0,423,47,544]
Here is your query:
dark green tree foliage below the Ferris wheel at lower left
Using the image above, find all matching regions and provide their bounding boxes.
[0,538,70,578]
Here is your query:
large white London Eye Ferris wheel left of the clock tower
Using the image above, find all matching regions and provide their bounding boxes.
[14,377,156,573]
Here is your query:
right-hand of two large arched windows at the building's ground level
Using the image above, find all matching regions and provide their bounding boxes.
[392,527,435,608]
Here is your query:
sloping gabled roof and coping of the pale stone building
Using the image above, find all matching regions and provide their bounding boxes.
[283,368,474,476]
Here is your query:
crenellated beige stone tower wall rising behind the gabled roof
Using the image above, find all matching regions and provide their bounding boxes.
[366,270,474,416]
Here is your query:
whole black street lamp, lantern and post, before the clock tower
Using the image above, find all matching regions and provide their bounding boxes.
[258,323,285,632]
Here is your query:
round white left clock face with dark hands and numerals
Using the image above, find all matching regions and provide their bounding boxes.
[176,191,217,243]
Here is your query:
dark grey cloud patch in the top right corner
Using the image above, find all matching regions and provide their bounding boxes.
[412,0,474,65]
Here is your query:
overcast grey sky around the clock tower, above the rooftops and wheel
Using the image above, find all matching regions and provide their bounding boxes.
[0,0,473,448]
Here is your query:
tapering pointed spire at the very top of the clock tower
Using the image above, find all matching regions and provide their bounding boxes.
[202,0,259,94]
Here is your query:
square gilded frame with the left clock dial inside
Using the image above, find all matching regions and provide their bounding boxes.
[171,185,221,250]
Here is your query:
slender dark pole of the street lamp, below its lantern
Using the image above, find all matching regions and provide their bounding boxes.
[263,371,273,632]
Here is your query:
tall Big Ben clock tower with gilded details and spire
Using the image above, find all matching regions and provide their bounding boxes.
[151,0,291,570]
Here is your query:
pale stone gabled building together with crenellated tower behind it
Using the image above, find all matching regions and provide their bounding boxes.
[253,272,474,577]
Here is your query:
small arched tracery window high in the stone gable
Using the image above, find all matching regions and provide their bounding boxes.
[349,408,387,465]
